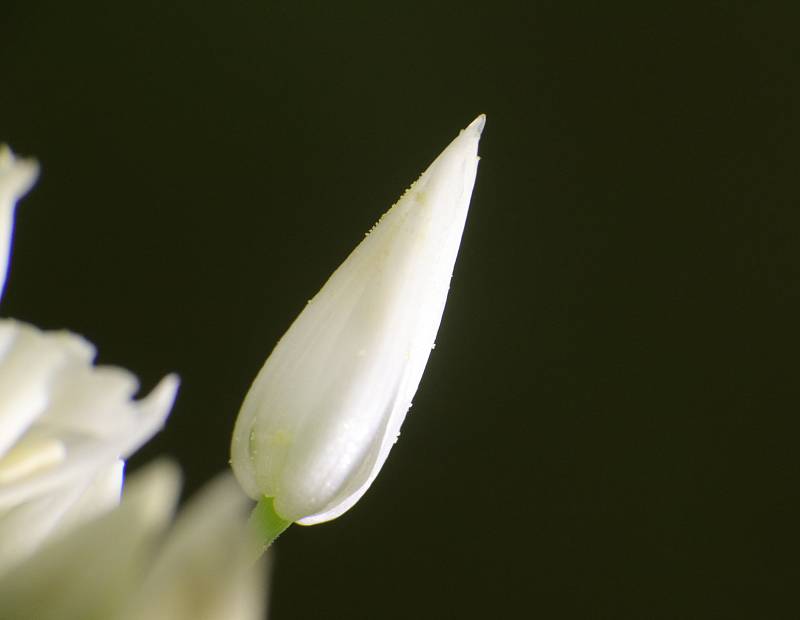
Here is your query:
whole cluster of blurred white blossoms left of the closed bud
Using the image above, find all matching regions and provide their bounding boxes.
[0,146,264,620]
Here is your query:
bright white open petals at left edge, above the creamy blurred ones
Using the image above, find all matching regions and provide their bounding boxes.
[0,146,178,572]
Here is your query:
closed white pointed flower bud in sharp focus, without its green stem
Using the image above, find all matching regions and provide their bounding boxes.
[231,115,485,525]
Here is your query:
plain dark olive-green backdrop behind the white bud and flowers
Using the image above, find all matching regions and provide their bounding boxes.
[0,0,800,620]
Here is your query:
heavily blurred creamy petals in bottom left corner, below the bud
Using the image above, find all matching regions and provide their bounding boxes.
[0,462,265,620]
